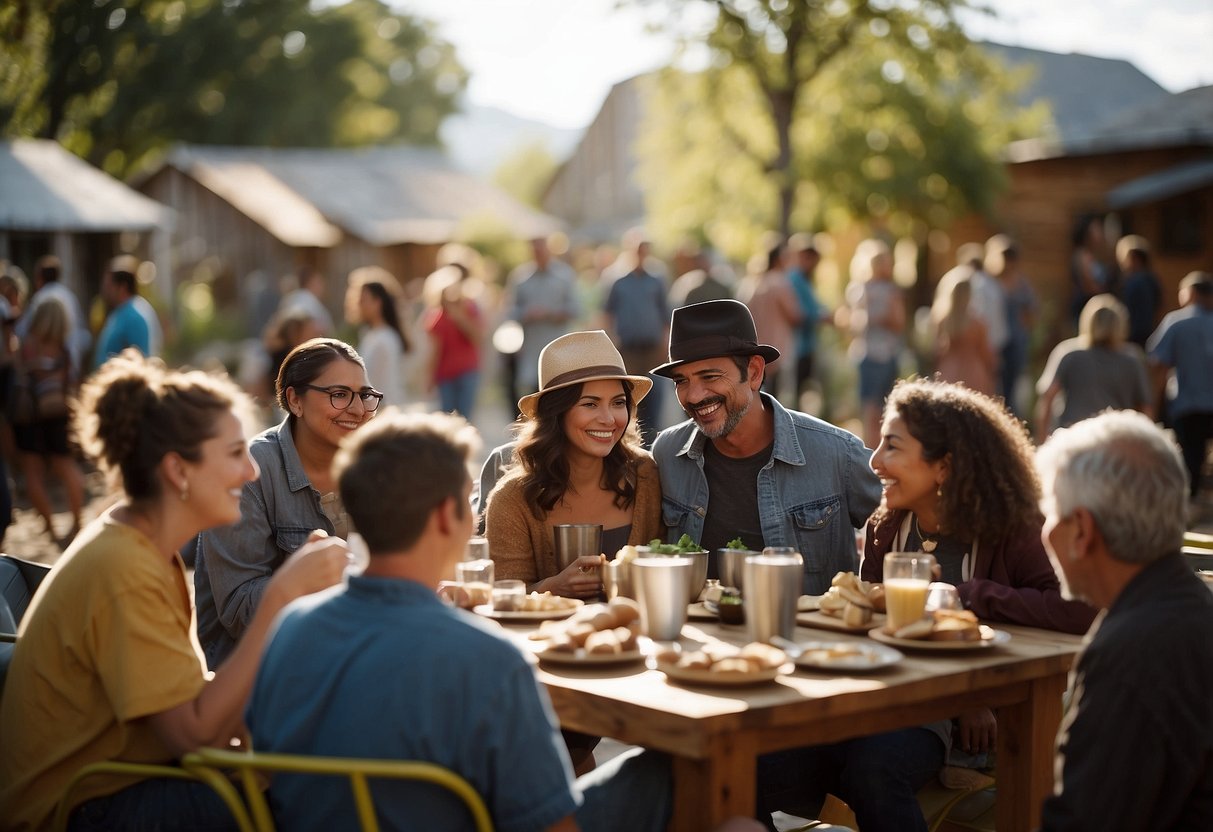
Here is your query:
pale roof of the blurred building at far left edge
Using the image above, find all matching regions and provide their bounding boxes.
[0,138,172,232]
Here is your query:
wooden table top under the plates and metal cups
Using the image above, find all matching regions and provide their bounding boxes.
[487,613,1082,758]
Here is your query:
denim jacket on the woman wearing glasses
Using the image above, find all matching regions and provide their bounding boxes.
[194,418,334,669]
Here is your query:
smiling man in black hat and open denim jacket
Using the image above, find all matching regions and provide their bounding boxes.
[651,301,881,595]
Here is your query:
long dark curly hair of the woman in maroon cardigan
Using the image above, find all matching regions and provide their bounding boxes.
[872,378,1041,541]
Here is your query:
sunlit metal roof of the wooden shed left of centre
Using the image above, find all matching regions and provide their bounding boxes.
[160,146,562,246]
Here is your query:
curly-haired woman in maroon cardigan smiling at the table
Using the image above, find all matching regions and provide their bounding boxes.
[860,380,1094,633]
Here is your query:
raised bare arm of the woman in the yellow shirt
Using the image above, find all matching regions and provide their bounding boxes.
[147,537,349,756]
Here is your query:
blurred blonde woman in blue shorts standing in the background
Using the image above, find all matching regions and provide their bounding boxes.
[838,239,906,445]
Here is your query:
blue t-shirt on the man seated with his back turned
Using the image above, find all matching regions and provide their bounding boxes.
[246,577,581,832]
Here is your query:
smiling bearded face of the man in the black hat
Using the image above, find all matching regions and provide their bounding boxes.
[671,355,762,439]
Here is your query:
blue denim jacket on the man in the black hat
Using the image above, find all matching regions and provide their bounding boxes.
[653,393,881,595]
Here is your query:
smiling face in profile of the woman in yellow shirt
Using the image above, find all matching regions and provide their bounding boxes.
[173,411,260,529]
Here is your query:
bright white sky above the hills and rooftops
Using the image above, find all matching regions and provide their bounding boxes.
[400,0,1213,129]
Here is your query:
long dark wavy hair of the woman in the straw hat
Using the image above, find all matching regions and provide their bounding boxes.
[514,380,642,519]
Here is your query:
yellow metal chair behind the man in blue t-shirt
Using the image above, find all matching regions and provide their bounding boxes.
[183,748,492,832]
